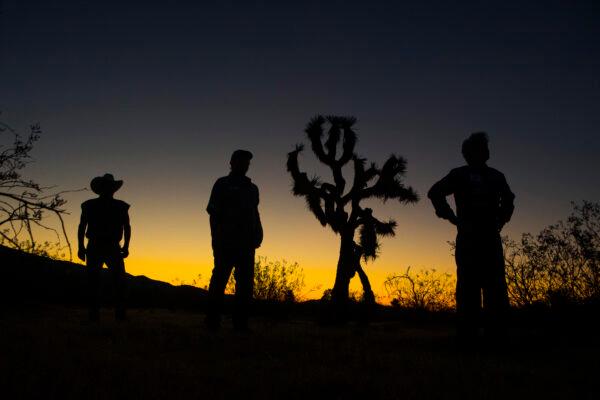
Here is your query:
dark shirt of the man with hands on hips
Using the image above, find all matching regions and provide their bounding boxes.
[428,165,515,233]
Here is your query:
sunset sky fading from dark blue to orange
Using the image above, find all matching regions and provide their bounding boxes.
[0,0,600,297]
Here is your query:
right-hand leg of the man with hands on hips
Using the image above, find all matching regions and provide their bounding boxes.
[483,236,509,340]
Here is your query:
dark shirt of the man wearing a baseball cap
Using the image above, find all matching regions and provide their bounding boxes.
[206,175,263,249]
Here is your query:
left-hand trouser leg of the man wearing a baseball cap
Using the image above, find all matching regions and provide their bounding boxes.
[206,250,233,329]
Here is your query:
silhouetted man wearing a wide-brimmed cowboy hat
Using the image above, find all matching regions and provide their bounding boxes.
[77,174,131,321]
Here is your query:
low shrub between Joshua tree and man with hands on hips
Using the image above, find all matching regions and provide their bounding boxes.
[384,267,456,311]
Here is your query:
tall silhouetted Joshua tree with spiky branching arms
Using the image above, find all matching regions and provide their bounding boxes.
[287,115,418,303]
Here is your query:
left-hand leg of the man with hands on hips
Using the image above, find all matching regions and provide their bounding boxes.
[455,235,481,342]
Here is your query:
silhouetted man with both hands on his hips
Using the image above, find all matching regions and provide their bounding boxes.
[428,132,515,344]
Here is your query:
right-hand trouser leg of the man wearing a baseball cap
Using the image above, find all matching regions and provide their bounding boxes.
[233,249,254,330]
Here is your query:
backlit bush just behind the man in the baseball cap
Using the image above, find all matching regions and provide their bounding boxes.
[225,257,304,302]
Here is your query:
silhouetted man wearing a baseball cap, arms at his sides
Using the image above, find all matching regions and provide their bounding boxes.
[206,150,263,331]
